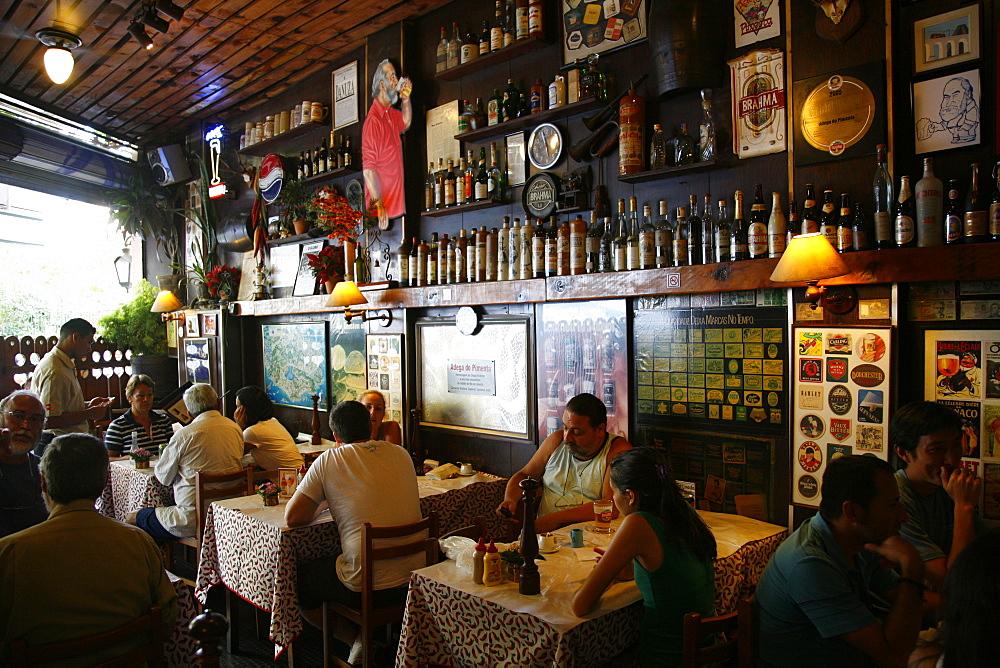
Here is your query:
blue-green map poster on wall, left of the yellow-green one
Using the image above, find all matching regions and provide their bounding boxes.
[261,322,329,409]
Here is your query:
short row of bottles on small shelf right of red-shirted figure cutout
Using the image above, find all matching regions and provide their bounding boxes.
[424,142,507,211]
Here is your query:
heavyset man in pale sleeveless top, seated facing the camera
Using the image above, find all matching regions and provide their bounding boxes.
[497,392,632,533]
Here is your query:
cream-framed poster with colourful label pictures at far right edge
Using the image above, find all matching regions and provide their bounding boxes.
[924,329,1000,520]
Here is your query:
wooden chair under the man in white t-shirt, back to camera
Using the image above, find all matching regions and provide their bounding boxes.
[323,512,438,668]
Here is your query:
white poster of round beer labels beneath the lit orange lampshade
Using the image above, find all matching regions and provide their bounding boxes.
[790,327,892,508]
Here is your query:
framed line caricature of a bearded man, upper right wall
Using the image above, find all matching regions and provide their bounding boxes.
[913,69,982,154]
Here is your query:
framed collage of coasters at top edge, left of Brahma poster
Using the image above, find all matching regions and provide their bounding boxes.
[559,0,648,65]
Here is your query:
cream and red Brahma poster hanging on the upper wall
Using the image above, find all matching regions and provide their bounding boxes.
[729,49,787,158]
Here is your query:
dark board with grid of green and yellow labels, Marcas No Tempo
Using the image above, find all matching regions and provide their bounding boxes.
[635,307,788,427]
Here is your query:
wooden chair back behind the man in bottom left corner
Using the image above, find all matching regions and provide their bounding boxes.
[10,605,167,668]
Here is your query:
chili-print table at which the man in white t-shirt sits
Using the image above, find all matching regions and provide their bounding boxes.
[195,472,507,657]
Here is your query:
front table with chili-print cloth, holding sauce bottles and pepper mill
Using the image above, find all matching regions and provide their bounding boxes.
[396,511,788,667]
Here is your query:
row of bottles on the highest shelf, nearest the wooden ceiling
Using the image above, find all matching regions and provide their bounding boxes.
[434,0,545,74]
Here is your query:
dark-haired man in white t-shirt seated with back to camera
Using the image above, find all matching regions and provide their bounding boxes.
[285,401,424,663]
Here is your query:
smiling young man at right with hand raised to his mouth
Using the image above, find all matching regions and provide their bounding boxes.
[889,401,983,591]
